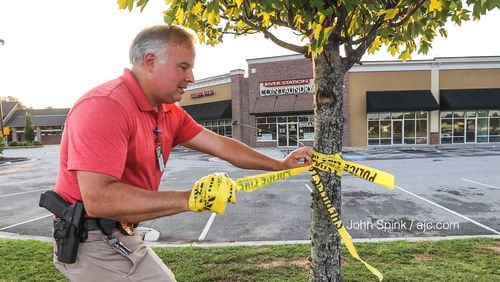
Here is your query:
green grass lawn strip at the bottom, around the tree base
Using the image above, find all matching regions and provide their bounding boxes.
[0,238,500,282]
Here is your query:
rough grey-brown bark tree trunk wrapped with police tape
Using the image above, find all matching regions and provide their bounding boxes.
[309,42,345,281]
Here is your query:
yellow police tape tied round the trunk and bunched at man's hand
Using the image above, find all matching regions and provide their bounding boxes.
[195,152,394,281]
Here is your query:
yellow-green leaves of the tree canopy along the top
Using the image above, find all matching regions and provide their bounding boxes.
[118,0,500,60]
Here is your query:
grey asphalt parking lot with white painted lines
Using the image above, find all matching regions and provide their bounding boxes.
[0,145,500,244]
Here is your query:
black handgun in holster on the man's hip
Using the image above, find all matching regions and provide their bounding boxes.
[39,191,84,263]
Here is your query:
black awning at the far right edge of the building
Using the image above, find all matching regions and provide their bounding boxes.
[439,88,500,111]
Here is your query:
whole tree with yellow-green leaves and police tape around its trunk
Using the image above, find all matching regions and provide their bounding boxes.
[118,0,500,281]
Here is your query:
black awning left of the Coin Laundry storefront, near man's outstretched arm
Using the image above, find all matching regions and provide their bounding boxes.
[182,100,232,121]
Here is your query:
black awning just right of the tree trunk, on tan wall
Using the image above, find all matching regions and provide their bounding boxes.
[366,90,439,113]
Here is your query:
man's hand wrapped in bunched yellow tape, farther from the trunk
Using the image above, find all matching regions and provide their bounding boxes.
[189,173,236,214]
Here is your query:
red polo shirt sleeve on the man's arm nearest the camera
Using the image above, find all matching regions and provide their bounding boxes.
[65,97,130,179]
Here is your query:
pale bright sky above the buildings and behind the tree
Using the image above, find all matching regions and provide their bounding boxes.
[0,0,500,109]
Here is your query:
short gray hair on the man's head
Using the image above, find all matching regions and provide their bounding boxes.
[129,25,196,65]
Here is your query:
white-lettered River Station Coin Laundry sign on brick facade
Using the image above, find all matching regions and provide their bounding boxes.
[259,78,314,96]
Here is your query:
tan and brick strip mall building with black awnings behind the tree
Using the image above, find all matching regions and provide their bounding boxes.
[181,55,500,147]
